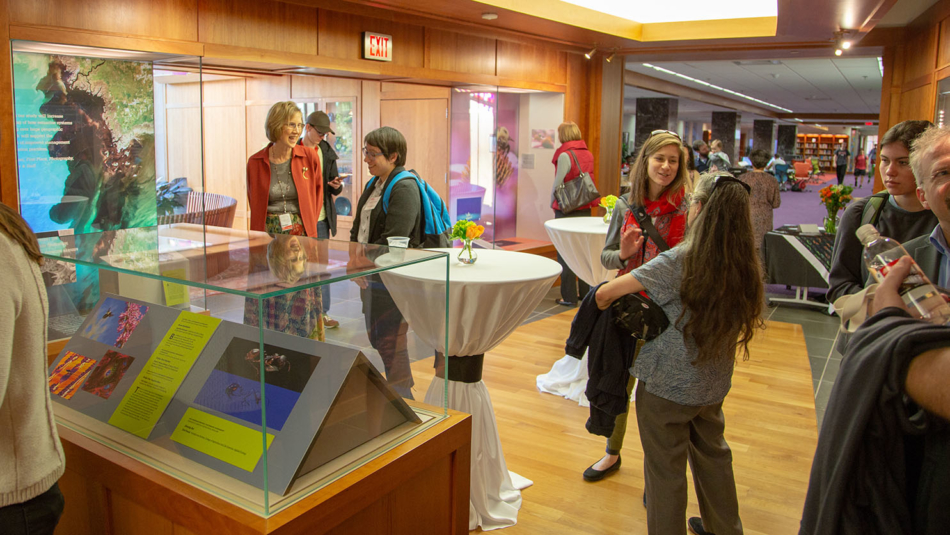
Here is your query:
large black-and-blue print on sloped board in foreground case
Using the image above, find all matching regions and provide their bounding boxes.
[195,338,320,431]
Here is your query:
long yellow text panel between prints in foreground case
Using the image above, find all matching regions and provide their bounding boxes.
[109,312,221,440]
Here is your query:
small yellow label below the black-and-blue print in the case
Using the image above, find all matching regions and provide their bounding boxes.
[172,408,274,472]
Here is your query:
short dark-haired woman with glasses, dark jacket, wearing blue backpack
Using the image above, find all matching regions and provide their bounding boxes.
[350,126,425,399]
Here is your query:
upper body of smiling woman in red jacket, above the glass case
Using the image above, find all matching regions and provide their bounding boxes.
[247,101,323,238]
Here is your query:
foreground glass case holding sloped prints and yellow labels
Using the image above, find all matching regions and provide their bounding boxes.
[40,223,449,516]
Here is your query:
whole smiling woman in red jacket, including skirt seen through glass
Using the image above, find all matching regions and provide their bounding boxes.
[244,101,324,340]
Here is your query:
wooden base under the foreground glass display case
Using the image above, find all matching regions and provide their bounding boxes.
[56,402,472,535]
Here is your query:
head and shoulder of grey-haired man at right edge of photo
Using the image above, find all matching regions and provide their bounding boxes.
[904,127,950,289]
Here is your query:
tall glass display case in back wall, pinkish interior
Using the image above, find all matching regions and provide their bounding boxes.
[448,86,564,251]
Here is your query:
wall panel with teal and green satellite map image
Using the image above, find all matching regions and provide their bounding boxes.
[13,52,156,233]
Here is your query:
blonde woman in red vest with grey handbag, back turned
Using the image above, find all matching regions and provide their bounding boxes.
[551,122,600,306]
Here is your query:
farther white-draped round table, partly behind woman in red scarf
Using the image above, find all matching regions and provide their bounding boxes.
[537,217,617,407]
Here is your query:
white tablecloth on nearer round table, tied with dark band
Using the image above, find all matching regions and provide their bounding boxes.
[377,249,561,531]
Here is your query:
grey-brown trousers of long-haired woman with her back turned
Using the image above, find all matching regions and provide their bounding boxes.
[635,381,742,535]
